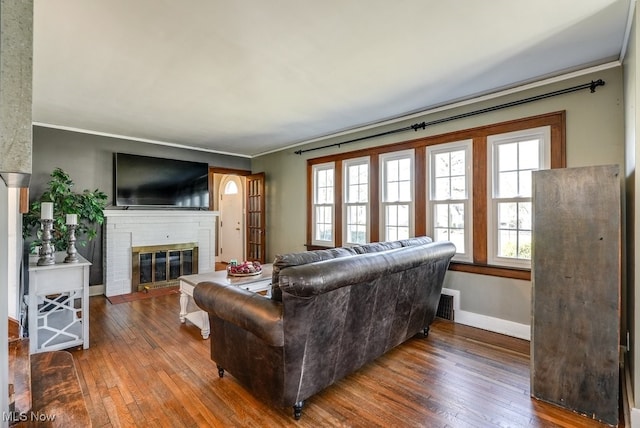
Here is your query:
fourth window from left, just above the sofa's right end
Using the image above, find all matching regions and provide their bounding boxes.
[427,140,473,262]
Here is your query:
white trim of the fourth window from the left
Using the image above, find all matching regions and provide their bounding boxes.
[426,139,473,263]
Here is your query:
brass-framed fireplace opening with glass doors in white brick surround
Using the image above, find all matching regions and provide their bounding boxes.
[131,242,198,292]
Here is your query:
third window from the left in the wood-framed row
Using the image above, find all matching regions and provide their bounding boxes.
[380,150,414,241]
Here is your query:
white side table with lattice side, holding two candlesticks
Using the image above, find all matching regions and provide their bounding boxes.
[27,251,91,354]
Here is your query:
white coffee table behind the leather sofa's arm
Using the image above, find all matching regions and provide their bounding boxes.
[178,263,273,339]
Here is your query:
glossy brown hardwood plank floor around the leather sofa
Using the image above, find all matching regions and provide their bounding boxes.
[72,294,624,428]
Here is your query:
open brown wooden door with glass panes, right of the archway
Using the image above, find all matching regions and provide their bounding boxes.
[245,172,266,263]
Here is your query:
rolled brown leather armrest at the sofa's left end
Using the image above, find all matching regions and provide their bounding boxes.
[193,281,284,346]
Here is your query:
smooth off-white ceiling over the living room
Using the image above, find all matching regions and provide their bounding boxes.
[33,0,630,156]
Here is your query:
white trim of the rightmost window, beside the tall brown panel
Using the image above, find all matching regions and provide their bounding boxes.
[487,126,551,269]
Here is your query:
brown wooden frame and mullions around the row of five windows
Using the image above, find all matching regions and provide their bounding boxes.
[305,110,566,280]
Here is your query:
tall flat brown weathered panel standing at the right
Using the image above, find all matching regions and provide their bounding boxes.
[531,165,621,425]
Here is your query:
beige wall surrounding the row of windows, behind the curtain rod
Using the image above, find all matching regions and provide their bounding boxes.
[252,66,624,337]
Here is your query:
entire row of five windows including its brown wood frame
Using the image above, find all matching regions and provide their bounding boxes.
[306,111,566,280]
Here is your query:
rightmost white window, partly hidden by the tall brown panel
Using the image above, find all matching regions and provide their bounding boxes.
[487,126,551,268]
